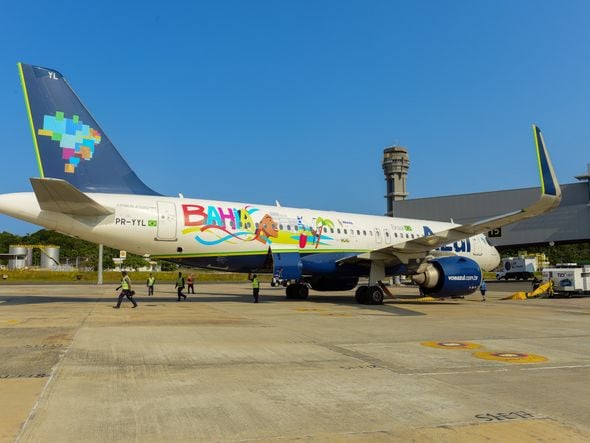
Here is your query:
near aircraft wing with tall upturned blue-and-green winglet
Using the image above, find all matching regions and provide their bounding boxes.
[345,125,561,262]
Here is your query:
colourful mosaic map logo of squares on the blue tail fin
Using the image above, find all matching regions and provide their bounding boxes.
[38,111,100,174]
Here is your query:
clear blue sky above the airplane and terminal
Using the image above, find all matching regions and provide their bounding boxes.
[0,0,590,234]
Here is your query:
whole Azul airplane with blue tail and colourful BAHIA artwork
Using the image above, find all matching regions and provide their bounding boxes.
[0,63,561,304]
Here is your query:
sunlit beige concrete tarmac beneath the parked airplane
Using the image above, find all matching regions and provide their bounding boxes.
[0,282,590,442]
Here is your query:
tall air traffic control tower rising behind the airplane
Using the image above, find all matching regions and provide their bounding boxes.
[382,146,410,217]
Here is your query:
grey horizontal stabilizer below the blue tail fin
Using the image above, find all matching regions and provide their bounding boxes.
[31,178,114,217]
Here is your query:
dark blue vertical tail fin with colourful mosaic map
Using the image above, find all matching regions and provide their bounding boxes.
[18,63,158,195]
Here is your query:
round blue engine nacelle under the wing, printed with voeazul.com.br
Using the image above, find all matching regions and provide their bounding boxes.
[412,256,482,297]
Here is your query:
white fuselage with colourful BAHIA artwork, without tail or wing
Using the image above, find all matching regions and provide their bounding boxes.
[0,192,500,271]
